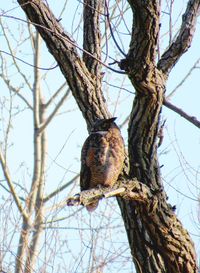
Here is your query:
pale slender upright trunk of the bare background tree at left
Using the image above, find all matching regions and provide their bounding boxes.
[25,32,47,273]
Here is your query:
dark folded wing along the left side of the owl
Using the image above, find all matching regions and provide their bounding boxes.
[80,138,91,191]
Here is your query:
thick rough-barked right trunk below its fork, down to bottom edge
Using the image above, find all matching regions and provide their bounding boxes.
[118,65,197,273]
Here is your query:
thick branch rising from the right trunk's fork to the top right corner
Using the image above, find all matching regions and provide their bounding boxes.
[158,0,200,76]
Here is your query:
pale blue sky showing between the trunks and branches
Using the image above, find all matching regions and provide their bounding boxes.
[0,0,200,272]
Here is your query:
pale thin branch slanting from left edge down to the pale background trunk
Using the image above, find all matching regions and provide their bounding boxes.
[0,149,28,220]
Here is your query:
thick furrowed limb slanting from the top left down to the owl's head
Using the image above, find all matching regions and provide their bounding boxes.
[18,0,110,128]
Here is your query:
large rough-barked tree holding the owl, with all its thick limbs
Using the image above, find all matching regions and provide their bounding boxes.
[18,0,200,273]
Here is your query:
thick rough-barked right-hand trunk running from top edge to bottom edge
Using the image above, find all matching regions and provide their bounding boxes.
[118,1,197,273]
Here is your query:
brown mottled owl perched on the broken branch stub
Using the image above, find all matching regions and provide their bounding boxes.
[80,118,125,211]
